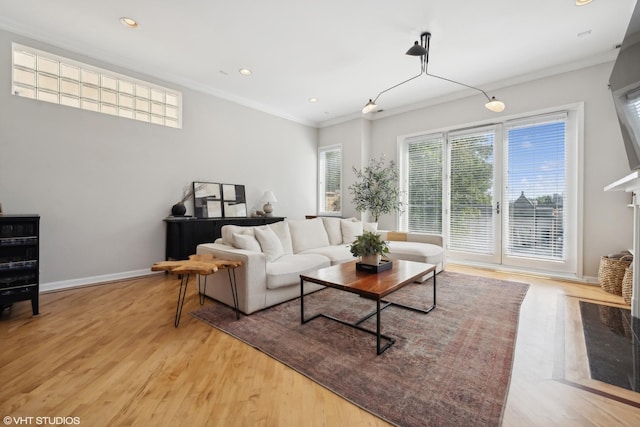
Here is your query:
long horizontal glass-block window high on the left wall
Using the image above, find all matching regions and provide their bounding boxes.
[12,43,182,128]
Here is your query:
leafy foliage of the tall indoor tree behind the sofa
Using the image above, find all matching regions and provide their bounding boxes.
[349,156,402,223]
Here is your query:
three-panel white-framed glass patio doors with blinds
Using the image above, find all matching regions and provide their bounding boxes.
[400,107,578,273]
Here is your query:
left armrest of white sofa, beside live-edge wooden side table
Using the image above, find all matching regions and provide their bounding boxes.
[196,243,267,314]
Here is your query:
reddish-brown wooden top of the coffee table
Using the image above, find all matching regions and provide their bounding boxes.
[300,260,436,298]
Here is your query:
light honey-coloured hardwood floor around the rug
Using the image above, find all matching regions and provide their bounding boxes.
[0,265,640,427]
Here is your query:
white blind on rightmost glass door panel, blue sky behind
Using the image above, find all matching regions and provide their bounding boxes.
[503,113,567,260]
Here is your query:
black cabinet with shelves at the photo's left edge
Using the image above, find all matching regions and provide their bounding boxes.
[0,214,40,316]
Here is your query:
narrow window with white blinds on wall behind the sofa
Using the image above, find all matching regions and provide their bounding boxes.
[318,145,342,216]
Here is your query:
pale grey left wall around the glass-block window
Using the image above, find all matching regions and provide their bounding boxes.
[0,31,317,289]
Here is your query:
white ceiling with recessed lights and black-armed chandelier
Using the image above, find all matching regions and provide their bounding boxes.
[0,0,636,126]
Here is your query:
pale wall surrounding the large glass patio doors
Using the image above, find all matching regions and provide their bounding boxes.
[328,63,632,277]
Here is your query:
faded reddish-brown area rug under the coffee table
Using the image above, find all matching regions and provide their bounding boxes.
[191,272,529,426]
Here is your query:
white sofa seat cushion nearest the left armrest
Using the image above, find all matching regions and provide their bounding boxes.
[266,254,330,289]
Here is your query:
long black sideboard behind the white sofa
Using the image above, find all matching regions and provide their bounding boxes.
[164,216,285,260]
